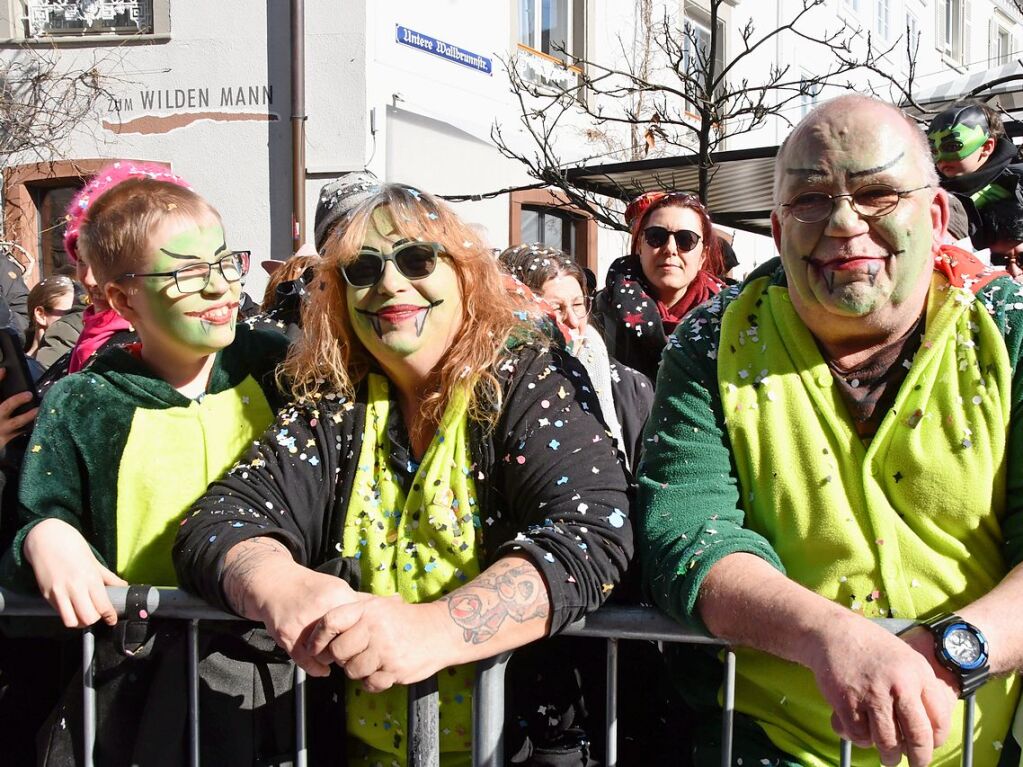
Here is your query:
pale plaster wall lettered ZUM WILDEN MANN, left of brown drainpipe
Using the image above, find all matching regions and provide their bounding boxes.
[0,0,292,296]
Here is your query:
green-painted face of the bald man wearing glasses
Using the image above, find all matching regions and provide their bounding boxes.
[780,109,934,325]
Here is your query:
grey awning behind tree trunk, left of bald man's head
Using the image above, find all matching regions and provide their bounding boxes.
[566,146,777,234]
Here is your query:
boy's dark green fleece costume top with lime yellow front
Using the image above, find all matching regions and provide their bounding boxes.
[6,329,286,587]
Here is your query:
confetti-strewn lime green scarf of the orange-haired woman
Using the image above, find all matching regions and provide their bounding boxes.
[342,374,480,765]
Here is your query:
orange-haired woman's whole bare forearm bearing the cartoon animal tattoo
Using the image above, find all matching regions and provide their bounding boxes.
[434,555,550,665]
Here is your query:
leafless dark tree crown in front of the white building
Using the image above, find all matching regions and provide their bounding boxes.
[491,0,924,228]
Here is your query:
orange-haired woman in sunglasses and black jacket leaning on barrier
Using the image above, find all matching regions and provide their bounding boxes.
[175,185,632,765]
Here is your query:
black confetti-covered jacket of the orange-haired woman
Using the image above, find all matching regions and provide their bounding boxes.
[174,347,633,633]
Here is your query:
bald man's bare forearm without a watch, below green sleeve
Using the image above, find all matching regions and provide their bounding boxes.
[697,553,870,667]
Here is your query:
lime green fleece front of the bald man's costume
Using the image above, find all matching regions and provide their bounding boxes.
[718,275,1019,766]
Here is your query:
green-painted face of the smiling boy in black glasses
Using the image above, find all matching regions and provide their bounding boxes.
[126,219,241,355]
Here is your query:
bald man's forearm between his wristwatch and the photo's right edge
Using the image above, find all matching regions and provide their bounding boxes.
[957,565,1023,674]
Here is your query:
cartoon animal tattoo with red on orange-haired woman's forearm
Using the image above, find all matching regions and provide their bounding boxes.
[445,563,550,644]
